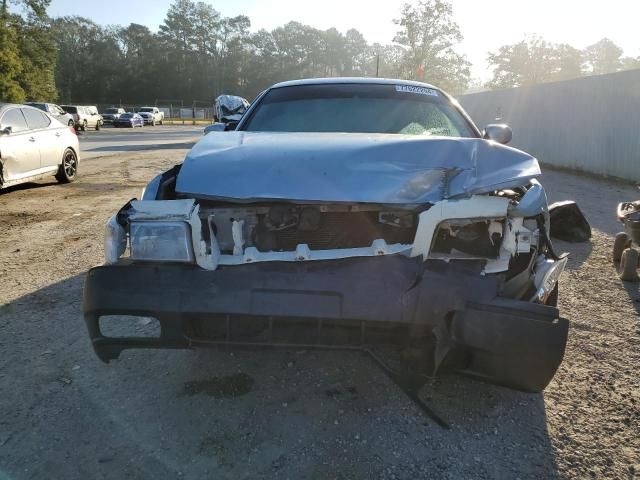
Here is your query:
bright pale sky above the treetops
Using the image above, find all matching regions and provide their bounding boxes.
[49,0,640,81]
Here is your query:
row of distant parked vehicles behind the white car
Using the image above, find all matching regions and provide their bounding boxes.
[25,102,164,131]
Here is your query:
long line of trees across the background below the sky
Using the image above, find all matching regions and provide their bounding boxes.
[0,0,640,104]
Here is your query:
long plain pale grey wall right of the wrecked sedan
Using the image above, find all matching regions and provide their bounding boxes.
[458,70,640,181]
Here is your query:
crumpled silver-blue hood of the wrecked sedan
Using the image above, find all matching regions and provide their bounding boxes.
[176,132,541,204]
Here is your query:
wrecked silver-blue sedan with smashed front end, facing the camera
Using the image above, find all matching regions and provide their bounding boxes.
[84,79,568,391]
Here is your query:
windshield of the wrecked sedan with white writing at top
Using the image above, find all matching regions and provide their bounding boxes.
[242,84,477,137]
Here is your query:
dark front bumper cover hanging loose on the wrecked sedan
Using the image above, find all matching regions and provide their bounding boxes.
[83,256,568,391]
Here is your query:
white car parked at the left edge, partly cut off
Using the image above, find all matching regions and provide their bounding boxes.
[0,103,80,189]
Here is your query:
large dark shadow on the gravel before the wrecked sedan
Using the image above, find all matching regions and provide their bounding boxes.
[0,275,557,480]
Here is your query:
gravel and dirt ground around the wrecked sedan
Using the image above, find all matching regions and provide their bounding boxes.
[0,144,640,479]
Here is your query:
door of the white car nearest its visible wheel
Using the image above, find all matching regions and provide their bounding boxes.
[0,108,40,182]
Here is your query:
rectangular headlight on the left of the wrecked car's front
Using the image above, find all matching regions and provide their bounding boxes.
[129,221,194,262]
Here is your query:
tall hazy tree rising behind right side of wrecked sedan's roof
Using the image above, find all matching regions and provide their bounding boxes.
[394,0,470,92]
